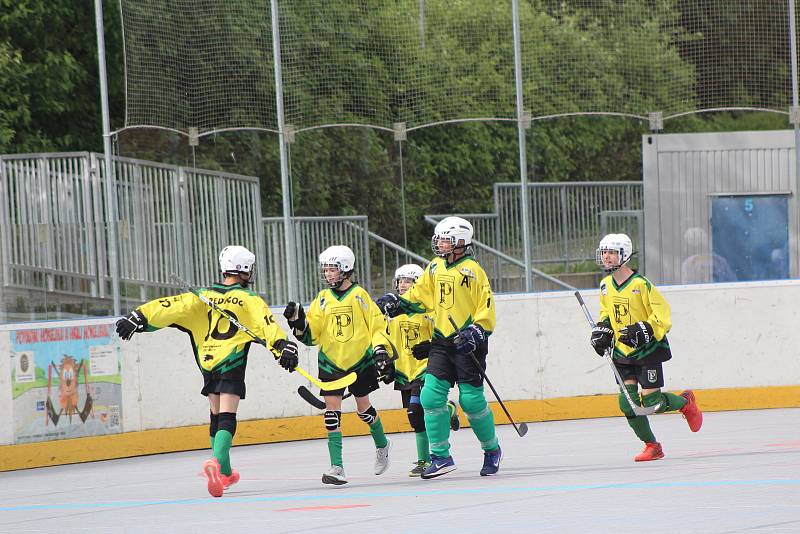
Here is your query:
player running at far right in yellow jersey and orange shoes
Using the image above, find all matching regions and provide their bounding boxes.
[591,234,703,462]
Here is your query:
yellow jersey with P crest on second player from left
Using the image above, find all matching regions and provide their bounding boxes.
[300,284,391,373]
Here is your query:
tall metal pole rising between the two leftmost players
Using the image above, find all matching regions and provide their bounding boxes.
[270,0,299,300]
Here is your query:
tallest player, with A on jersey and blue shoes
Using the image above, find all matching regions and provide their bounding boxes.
[386,217,503,479]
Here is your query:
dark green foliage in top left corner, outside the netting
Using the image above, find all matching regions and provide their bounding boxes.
[0,0,123,154]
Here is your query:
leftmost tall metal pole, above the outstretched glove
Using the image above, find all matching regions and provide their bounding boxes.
[94,0,121,315]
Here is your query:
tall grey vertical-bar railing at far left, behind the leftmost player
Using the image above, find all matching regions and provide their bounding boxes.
[0,152,264,314]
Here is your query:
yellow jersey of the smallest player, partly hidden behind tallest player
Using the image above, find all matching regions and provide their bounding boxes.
[386,314,433,386]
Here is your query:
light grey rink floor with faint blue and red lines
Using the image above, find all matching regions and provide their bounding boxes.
[0,409,800,534]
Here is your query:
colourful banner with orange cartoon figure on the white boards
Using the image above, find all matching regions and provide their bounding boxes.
[10,323,122,443]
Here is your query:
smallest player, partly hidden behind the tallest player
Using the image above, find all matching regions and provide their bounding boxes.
[376,263,460,477]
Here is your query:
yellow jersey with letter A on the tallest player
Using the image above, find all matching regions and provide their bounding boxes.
[400,255,497,339]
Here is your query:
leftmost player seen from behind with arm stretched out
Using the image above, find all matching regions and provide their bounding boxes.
[116,246,298,497]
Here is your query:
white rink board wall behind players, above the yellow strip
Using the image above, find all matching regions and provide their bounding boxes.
[0,281,800,445]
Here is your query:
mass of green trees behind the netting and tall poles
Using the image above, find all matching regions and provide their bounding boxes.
[0,0,788,253]
